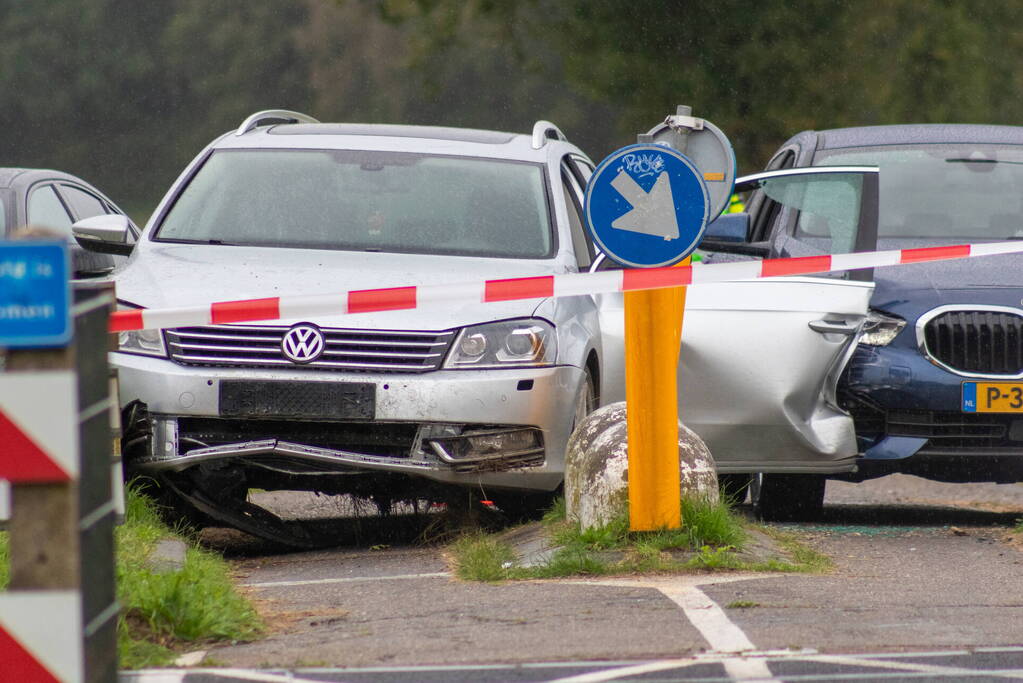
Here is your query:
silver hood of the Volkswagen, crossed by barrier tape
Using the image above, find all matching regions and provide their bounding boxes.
[114,242,564,330]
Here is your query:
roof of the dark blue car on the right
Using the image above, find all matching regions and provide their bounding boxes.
[816,124,1023,149]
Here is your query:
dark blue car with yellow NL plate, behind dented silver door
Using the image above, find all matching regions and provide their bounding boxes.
[703,125,1023,519]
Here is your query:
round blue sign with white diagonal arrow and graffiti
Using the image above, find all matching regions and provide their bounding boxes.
[585,144,710,268]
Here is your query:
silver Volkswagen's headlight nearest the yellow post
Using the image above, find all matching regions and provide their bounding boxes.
[444,318,558,369]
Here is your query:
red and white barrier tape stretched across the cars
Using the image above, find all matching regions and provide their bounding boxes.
[109,241,1023,332]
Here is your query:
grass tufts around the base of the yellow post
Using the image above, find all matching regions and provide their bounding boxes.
[451,498,765,582]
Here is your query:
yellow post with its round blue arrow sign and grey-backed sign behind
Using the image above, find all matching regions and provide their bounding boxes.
[585,106,736,531]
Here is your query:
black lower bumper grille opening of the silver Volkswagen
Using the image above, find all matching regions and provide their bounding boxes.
[178,417,419,458]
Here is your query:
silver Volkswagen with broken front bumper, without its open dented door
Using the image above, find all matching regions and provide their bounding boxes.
[113,110,602,540]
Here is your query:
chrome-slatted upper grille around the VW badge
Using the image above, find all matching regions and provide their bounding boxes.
[167,325,454,372]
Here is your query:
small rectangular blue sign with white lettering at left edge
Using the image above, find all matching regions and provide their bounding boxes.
[0,241,71,349]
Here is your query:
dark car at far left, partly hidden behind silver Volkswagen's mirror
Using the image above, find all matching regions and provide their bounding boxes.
[0,168,139,277]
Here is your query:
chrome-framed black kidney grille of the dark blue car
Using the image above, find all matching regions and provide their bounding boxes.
[924,311,1023,375]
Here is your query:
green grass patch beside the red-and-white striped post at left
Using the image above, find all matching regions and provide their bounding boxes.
[0,486,263,669]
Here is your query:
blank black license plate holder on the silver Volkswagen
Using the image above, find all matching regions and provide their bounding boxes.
[220,379,376,420]
